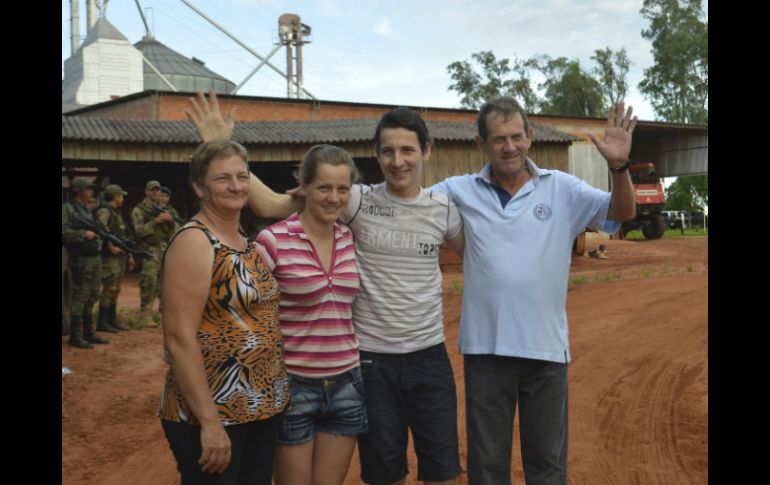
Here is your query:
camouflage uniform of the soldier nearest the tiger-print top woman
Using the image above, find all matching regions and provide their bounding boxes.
[131,199,177,312]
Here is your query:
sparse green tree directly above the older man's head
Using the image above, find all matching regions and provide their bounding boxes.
[447,51,538,111]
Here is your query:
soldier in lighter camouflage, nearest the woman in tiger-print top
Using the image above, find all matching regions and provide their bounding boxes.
[131,180,177,326]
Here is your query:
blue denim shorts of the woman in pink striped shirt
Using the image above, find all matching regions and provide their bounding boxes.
[278,367,369,445]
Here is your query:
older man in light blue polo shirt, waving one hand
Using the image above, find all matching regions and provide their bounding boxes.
[432,97,637,485]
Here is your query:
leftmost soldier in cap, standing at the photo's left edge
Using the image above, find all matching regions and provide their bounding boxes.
[61,177,109,349]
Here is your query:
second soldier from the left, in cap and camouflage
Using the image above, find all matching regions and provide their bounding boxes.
[94,185,134,333]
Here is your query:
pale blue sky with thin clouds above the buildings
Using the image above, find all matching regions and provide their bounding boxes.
[62,0,696,120]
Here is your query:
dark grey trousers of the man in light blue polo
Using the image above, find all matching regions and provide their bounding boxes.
[464,354,568,485]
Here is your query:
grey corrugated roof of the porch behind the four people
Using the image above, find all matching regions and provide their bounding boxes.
[62,116,580,144]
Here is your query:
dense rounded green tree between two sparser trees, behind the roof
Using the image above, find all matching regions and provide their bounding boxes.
[536,55,606,117]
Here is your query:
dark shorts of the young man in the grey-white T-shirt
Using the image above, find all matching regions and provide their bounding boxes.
[358,343,461,485]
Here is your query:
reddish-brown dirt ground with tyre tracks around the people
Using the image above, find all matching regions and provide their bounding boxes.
[62,238,708,485]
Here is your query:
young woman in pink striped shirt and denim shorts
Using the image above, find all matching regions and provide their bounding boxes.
[257,145,368,485]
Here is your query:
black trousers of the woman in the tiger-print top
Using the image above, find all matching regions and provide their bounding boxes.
[160,415,281,485]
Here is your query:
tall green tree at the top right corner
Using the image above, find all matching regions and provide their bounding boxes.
[639,0,708,123]
